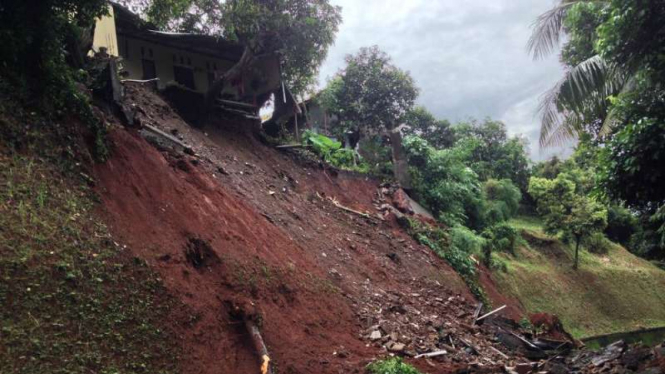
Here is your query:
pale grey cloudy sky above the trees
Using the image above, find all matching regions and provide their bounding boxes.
[319,0,568,160]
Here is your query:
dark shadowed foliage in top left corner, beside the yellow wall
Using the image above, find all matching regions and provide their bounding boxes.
[0,0,108,160]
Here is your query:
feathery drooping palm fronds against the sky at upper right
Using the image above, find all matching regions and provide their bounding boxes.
[527,0,632,146]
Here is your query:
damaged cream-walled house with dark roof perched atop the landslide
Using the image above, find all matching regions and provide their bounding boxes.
[92,3,282,119]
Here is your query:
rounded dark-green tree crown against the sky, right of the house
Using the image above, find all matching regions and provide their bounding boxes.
[324,46,418,133]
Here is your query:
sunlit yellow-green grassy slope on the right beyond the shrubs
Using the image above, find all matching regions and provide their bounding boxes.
[495,215,665,338]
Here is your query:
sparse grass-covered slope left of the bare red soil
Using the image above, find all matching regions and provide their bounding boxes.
[0,152,179,374]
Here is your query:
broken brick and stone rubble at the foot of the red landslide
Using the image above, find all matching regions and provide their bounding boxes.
[357,280,526,367]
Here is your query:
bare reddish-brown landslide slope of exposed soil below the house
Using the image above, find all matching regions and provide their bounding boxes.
[95,85,475,373]
